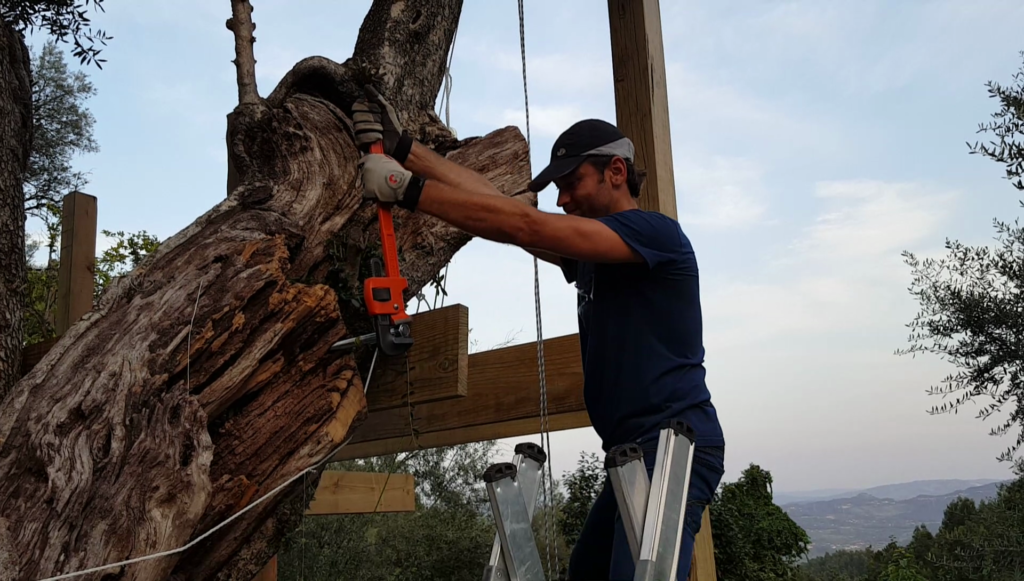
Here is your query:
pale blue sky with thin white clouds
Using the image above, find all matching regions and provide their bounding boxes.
[22,0,1024,491]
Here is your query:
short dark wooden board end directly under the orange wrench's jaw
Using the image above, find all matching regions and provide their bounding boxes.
[367,304,469,412]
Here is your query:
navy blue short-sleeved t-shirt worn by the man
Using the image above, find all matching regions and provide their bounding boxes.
[562,209,725,451]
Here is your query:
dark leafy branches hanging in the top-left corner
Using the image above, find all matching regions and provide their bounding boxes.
[0,0,114,69]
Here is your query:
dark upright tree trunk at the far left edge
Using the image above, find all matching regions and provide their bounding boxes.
[0,18,32,409]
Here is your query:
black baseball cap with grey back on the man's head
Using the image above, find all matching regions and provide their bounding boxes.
[529,119,634,192]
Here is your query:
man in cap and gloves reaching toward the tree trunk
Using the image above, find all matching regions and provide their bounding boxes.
[353,87,725,580]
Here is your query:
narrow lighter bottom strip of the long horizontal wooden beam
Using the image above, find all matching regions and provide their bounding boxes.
[333,411,590,462]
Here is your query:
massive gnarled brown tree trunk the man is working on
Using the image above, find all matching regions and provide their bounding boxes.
[0,0,536,581]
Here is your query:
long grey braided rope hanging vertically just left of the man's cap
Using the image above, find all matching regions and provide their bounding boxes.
[518,0,560,579]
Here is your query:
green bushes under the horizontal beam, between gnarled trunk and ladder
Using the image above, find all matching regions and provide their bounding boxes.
[279,442,495,581]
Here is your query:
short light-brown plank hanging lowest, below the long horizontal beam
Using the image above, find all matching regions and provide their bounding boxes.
[306,470,416,515]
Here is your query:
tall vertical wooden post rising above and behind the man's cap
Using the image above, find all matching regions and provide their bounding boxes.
[608,0,676,217]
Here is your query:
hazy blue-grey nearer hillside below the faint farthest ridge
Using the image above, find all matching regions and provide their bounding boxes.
[776,480,1009,557]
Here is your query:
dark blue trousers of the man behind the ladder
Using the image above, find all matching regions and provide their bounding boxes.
[568,442,725,581]
